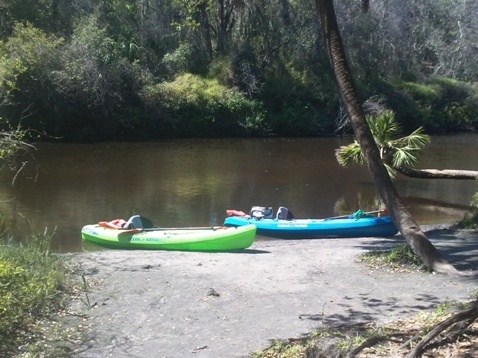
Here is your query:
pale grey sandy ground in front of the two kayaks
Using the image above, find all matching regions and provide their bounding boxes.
[69,230,478,358]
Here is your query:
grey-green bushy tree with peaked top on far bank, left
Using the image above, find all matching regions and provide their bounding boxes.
[38,15,143,140]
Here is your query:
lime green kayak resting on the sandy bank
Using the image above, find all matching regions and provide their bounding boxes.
[81,223,256,251]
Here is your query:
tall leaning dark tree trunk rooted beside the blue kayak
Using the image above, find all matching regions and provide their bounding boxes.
[316,0,457,273]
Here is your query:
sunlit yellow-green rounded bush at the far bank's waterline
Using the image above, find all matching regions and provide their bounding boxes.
[142,73,267,137]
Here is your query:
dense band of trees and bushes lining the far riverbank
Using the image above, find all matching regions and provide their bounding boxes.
[0,0,478,141]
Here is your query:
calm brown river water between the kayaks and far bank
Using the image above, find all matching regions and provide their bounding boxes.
[0,133,478,252]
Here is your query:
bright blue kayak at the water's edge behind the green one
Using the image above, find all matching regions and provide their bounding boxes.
[224,206,398,239]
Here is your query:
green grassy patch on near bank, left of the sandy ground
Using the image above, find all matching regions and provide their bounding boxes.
[0,230,72,357]
